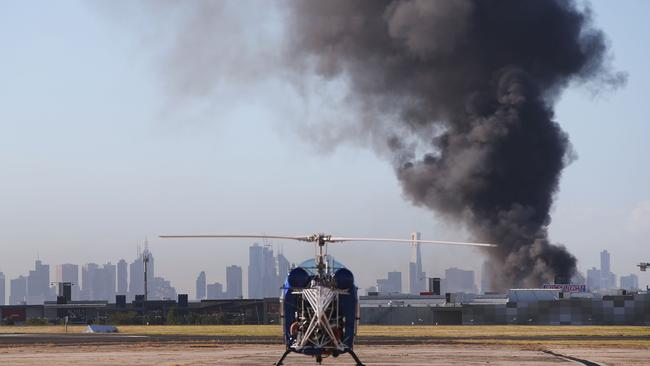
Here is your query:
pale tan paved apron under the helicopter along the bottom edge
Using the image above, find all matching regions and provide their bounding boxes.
[0,344,650,366]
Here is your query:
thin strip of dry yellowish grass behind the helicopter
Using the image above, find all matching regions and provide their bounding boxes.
[0,325,650,338]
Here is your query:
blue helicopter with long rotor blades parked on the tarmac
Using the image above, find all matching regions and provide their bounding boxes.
[160,233,496,366]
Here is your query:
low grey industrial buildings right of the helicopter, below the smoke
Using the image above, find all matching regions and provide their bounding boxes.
[359,289,650,325]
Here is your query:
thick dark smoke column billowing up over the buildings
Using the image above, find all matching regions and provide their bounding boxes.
[288,0,625,288]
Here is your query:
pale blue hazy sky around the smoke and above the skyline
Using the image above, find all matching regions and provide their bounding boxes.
[0,1,650,296]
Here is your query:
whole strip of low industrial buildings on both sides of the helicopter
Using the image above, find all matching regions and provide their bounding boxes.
[0,289,650,326]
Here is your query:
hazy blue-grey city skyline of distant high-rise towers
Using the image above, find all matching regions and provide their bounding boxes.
[0,240,647,304]
